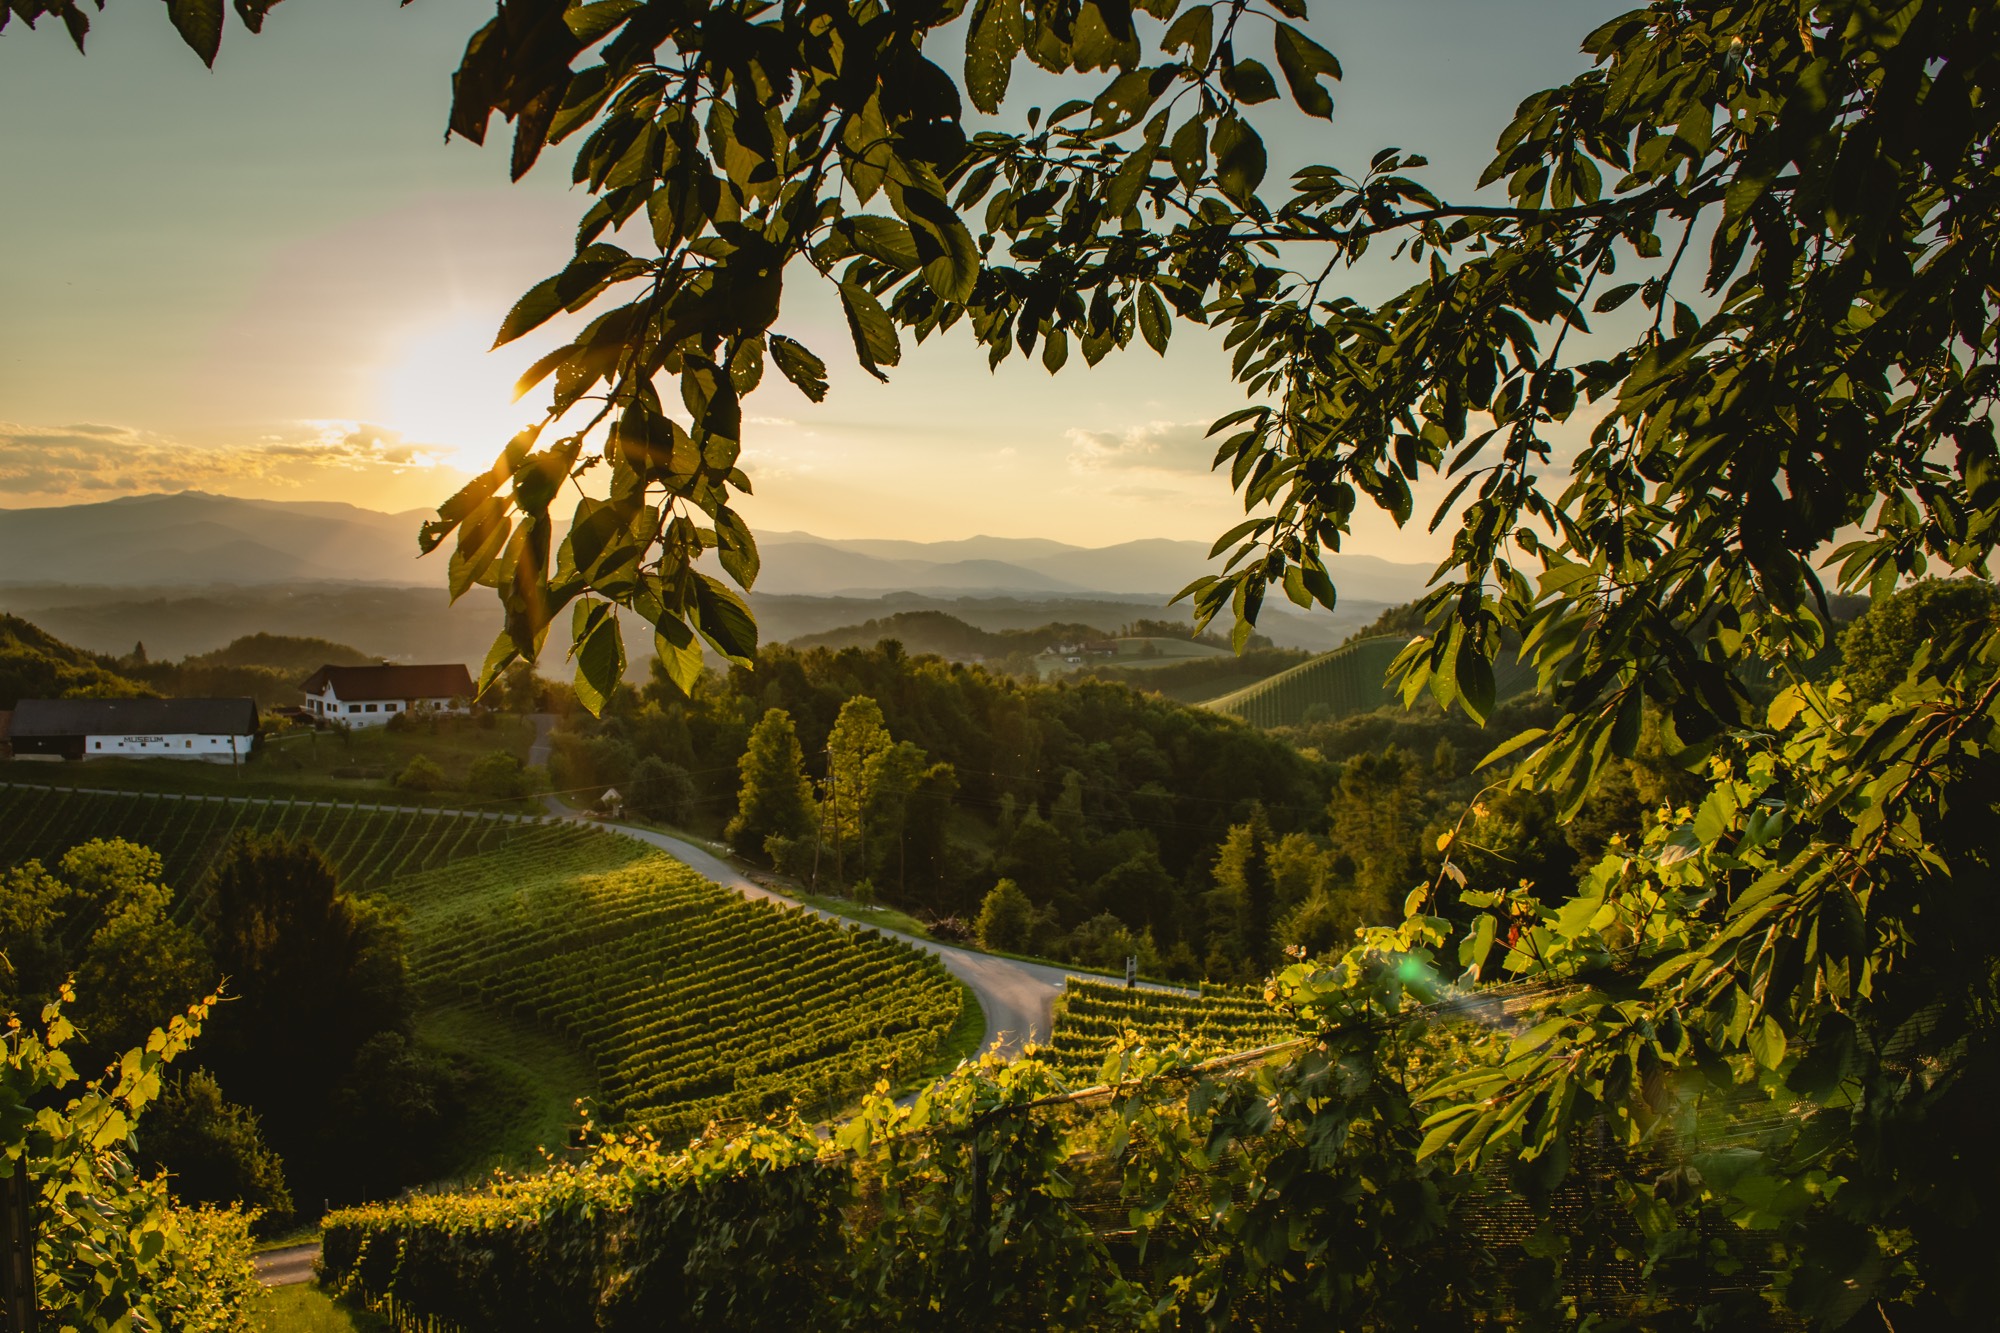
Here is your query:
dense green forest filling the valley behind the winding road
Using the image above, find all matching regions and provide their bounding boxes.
[550,642,1596,981]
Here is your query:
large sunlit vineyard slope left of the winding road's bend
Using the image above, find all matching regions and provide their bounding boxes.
[388,829,964,1135]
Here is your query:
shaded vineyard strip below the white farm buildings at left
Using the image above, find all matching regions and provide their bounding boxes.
[0,785,536,911]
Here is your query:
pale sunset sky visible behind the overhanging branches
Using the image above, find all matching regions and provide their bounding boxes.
[0,0,1630,560]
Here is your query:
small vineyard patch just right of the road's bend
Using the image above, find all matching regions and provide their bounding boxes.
[1038,977,1300,1083]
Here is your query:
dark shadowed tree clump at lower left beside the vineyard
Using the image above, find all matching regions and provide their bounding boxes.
[0,835,462,1229]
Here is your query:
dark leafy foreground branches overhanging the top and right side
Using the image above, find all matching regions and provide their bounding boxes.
[390,0,2000,1325]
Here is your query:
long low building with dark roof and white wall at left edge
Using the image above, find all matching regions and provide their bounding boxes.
[6,699,256,765]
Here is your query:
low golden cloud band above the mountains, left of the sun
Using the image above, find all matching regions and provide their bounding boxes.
[0,420,450,502]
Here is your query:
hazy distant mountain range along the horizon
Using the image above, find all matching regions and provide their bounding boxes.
[0,490,1430,602]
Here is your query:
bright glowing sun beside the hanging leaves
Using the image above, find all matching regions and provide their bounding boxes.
[376,314,542,472]
